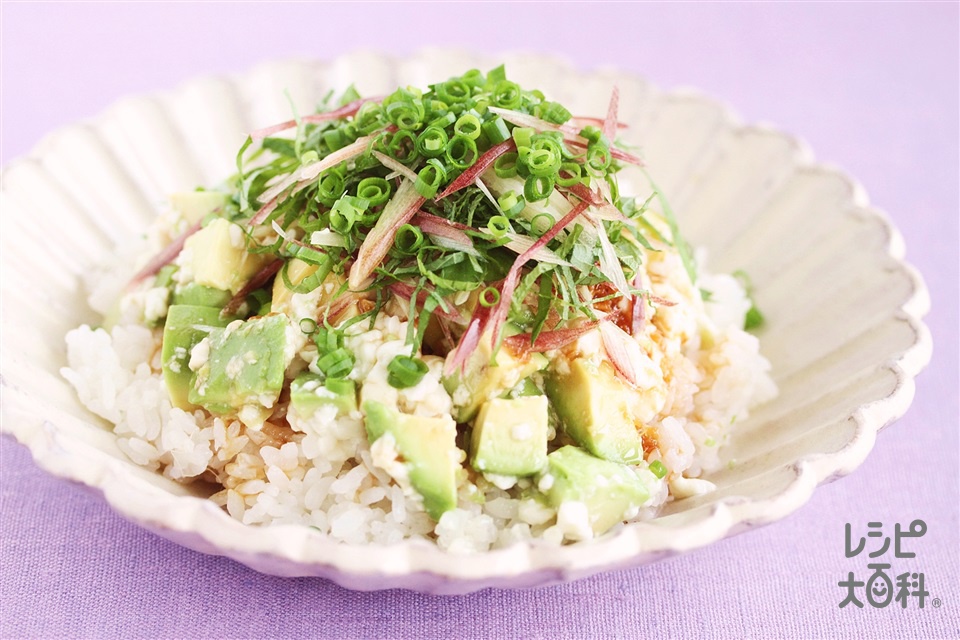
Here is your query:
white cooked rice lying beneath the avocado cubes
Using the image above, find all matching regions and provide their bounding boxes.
[62,219,776,552]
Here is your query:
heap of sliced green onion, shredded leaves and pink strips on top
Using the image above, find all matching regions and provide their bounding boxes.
[234,66,695,364]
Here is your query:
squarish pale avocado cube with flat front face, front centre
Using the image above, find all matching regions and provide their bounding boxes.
[470,395,547,477]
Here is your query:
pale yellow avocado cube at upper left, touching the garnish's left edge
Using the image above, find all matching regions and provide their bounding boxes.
[184,218,270,293]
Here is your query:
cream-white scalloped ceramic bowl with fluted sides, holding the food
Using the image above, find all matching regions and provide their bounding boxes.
[0,51,931,594]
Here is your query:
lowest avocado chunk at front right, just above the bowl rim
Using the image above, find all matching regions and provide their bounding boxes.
[540,446,653,535]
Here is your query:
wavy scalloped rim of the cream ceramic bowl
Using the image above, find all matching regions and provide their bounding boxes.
[0,50,932,594]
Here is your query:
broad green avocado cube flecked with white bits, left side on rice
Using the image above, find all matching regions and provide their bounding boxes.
[189,315,287,413]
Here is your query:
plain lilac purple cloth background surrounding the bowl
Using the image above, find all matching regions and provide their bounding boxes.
[0,2,960,638]
